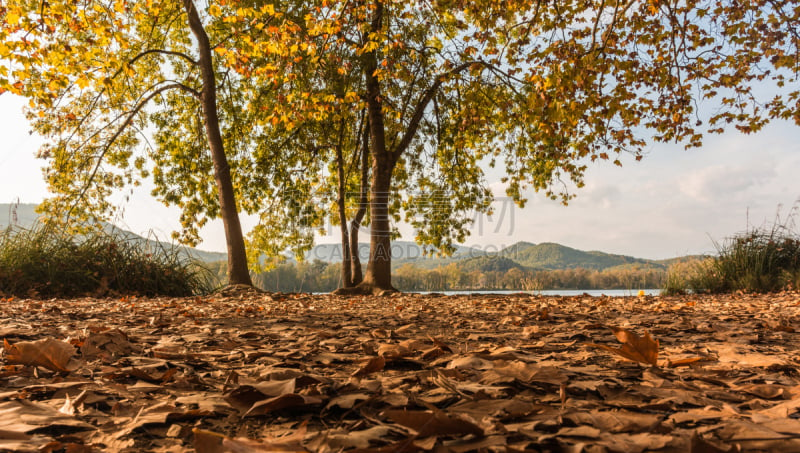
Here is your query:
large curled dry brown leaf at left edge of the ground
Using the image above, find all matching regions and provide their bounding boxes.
[3,338,80,372]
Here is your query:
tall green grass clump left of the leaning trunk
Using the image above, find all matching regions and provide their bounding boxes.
[0,225,214,297]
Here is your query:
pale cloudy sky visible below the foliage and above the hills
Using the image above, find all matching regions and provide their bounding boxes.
[0,93,800,259]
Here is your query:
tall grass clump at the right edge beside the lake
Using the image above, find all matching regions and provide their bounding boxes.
[662,209,800,295]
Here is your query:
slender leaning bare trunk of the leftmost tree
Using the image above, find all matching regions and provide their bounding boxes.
[183,0,253,286]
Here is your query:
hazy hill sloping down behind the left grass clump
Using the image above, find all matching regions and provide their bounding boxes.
[0,203,228,263]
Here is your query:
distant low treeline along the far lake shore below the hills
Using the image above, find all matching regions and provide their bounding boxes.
[212,260,667,292]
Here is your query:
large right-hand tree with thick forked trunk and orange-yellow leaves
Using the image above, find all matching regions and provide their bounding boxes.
[260,0,800,292]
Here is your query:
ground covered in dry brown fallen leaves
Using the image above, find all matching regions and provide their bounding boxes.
[0,290,800,453]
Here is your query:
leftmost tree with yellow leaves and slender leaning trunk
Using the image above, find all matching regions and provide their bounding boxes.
[0,0,296,285]
